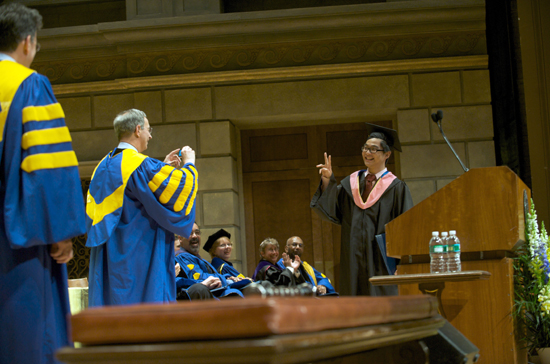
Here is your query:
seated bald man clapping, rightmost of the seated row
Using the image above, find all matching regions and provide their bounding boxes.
[277,236,338,296]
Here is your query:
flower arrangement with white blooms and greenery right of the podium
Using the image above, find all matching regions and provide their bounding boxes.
[513,200,550,351]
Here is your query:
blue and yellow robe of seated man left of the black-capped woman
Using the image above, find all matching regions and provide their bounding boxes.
[172,253,243,297]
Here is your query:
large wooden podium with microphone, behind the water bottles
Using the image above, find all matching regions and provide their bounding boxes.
[386,167,531,364]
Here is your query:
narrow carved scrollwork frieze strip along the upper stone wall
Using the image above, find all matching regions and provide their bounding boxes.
[33,31,486,84]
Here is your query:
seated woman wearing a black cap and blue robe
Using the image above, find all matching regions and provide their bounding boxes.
[203,229,253,282]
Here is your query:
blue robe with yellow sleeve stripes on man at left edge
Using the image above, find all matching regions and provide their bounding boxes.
[0,60,86,363]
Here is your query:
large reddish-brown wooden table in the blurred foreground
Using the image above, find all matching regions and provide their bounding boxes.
[57,295,446,364]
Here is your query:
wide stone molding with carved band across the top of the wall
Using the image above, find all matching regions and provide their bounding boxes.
[33,0,486,84]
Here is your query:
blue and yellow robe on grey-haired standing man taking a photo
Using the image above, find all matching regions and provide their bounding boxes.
[86,149,198,306]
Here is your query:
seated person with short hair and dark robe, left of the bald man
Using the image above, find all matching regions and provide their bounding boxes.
[253,238,305,287]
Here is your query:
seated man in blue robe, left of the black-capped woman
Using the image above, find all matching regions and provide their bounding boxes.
[176,223,243,298]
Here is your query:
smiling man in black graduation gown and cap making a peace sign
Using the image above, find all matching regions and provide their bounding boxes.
[311,124,413,296]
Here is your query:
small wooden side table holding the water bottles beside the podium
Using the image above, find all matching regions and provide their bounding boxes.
[370,270,491,318]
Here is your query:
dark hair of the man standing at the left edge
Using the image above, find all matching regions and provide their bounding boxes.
[0,3,42,53]
